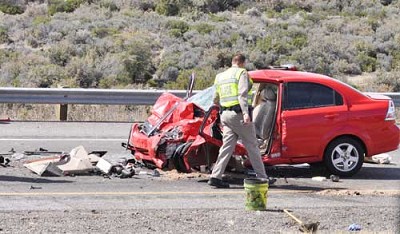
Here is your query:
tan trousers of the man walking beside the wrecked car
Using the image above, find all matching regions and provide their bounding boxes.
[211,111,267,179]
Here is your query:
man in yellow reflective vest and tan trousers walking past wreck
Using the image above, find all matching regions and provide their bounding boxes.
[208,54,267,188]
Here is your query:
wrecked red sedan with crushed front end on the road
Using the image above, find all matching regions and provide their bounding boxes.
[127,66,400,176]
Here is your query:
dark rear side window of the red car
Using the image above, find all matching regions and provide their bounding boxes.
[283,82,343,110]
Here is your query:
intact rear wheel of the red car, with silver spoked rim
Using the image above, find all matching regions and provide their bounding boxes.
[324,137,365,177]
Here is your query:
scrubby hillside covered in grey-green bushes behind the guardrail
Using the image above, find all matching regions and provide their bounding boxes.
[0,0,400,92]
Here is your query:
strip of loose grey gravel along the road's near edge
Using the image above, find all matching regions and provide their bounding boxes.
[0,207,400,233]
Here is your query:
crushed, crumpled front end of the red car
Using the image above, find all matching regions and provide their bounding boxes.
[126,87,246,172]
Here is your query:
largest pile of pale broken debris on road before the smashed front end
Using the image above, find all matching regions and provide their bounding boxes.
[24,146,135,178]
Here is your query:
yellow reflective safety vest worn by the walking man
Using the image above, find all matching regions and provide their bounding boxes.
[214,67,253,107]
